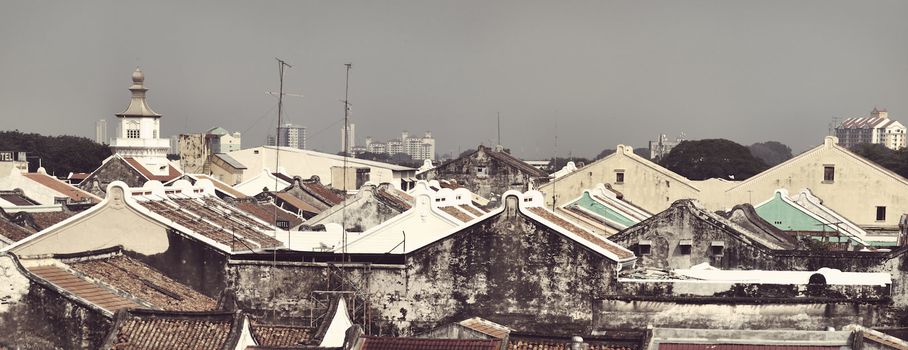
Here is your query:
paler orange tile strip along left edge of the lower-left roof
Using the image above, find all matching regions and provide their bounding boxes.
[28,265,142,312]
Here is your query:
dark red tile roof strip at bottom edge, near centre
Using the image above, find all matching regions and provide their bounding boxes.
[361,337,501,350]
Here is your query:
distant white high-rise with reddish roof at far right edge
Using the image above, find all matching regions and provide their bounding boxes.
[835,108,906,150]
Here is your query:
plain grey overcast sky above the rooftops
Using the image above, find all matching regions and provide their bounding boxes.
[0,0,908,158]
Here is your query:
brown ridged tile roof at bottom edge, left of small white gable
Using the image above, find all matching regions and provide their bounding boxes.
[101,310,243,350]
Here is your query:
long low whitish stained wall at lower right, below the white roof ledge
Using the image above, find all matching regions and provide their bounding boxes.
[594,299,897,331]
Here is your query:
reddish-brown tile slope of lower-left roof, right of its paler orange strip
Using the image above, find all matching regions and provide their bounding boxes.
[69,255,217,311]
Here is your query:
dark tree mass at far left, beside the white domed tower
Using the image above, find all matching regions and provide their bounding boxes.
[0,130,111,177]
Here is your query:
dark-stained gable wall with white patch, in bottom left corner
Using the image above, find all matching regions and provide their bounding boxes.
[0,255,111,349]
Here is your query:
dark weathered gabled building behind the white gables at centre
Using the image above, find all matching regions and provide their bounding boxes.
[420,147,544,202]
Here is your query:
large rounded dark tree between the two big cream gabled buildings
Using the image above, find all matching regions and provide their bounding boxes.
[659,139,768,180]
